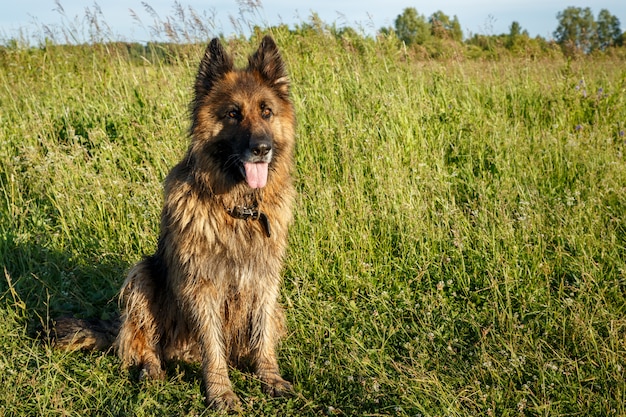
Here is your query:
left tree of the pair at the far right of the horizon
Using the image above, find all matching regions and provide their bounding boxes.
[554,7,597,53]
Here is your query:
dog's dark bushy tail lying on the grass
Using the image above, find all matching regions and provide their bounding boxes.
[50,317,121,350]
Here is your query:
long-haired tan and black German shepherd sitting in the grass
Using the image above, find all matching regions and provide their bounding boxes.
[53,36,295,410]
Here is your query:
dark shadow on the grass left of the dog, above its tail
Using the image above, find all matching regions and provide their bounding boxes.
[0,235,130,333]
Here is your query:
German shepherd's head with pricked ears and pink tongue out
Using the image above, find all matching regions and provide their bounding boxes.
[191,36,294,188]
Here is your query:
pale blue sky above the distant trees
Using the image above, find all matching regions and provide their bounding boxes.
[0,0,626,42]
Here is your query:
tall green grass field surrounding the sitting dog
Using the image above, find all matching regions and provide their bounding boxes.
[0,26,626,416]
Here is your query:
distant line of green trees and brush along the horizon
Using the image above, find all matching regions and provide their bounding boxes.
[0,7,626,61]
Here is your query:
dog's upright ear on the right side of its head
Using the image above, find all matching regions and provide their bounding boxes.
[248,35,289,98]
